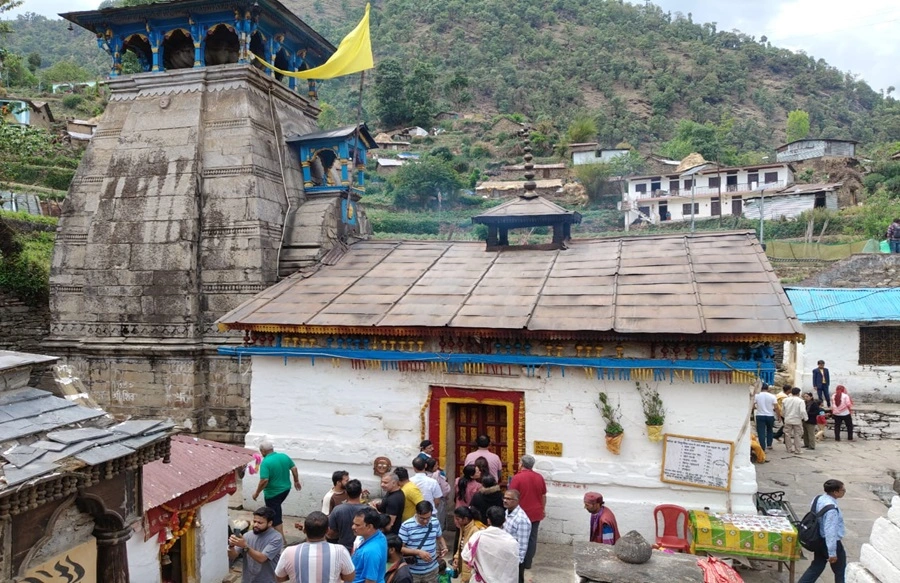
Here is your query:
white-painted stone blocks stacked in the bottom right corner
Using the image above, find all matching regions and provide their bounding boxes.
[846,496,900,583]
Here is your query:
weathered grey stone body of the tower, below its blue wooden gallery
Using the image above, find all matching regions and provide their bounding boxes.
[42,65,340,441]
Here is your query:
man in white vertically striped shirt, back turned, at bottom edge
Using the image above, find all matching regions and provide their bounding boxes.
[275,512,356,583]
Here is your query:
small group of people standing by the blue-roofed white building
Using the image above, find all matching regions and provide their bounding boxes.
[754,360,853,461]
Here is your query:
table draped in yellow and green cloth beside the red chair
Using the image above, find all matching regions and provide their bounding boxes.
[690,510,800,583]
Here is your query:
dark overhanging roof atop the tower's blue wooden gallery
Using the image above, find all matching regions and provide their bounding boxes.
[60,0,337,62]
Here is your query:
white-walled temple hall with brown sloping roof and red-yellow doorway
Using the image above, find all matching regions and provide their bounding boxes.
[219,220,802,543]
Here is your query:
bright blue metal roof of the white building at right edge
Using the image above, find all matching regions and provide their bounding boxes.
[784,287,900,324]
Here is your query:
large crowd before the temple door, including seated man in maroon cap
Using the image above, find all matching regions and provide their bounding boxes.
[228,435,619,583]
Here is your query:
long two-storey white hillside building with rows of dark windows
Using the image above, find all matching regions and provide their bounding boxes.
[621,164,794,225]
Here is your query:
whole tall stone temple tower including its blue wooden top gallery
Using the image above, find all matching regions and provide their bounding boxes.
[46,0,373,440]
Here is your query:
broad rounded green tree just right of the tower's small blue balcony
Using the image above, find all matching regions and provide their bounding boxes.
[388,156,462,209]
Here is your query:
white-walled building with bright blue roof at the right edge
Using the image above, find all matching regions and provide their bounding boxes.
[784,287,900,402]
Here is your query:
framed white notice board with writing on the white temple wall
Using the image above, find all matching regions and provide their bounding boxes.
[659,433,734,490]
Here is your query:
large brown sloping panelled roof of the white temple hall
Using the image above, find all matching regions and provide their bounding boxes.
[219,232,801,338]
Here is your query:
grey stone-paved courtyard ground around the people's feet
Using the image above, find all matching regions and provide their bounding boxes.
[227,438,900,583]
